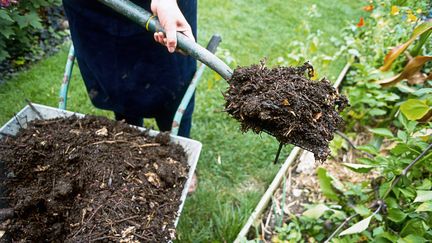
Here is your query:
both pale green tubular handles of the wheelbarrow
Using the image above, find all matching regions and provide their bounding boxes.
[58,34,222,135]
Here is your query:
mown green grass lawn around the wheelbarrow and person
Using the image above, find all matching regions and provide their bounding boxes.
[0,0,362,242]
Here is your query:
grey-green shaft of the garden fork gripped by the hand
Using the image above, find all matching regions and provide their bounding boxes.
[98,0,232,80]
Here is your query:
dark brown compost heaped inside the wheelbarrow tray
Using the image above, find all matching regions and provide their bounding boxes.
[0,117,188,242]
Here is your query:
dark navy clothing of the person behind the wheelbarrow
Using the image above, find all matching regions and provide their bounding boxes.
[63,0,197,136]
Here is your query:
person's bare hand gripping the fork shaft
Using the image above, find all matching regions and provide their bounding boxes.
[151,0,195,53]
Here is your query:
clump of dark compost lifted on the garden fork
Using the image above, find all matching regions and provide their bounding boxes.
[224,62,348,161]
